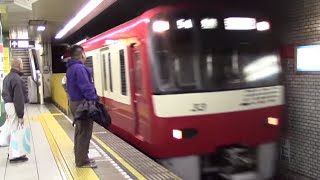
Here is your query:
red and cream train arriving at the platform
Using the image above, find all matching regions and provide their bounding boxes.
[82,6,284,179]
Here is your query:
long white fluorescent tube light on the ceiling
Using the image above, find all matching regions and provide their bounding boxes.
[55,0,103,39]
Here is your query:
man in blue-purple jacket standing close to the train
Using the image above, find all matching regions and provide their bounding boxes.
[66,45,97,168]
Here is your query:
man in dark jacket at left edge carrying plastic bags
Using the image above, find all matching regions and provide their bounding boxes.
[1,58,28,162]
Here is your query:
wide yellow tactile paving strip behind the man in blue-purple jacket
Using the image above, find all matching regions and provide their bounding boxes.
[32,114,99,180]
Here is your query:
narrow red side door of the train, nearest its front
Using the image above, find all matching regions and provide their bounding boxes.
[132,44,143,135]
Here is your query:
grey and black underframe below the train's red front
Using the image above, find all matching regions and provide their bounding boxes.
[159,142,277,180]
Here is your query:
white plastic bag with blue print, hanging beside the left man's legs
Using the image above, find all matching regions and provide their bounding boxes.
[9,126,31,159]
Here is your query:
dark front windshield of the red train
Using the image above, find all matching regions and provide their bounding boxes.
[150,10,281,94]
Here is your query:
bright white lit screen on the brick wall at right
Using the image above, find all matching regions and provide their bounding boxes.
[296,45,320,72]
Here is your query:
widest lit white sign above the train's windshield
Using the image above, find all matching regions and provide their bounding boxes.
[224,17,257,30]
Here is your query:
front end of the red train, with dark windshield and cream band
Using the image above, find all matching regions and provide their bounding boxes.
[148,7,284,179]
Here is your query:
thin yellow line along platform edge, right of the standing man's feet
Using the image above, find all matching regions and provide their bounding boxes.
[92,135,146,180]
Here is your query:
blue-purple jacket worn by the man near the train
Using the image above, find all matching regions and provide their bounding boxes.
[67,59,98,101]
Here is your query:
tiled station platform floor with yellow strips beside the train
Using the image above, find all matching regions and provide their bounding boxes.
[0,104,181,180]
